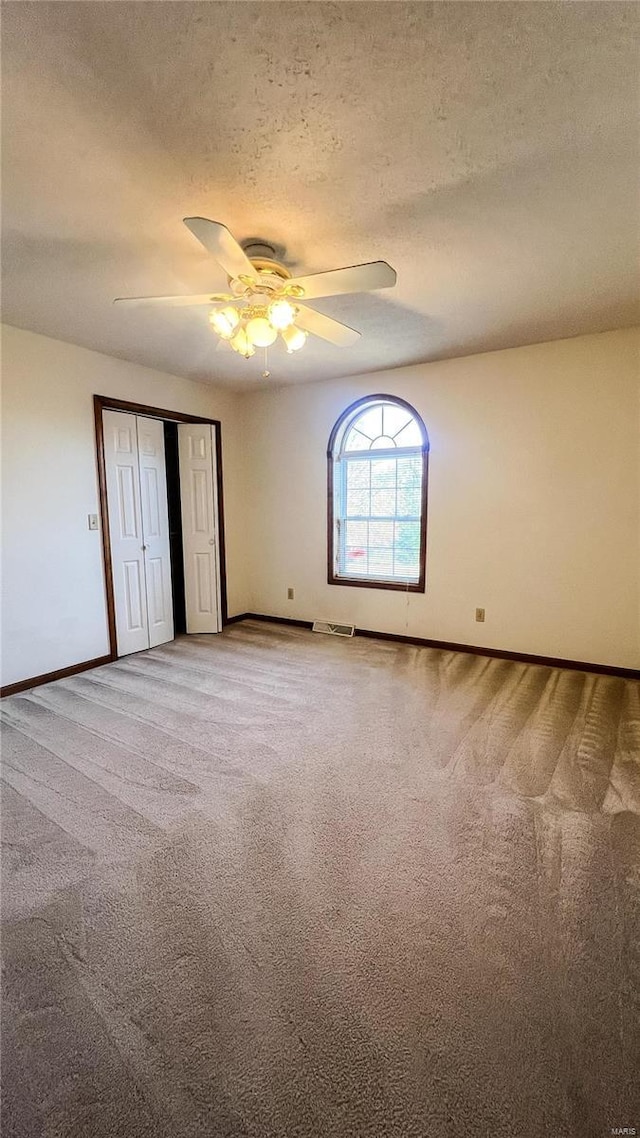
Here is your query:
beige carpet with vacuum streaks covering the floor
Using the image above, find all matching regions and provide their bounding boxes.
[2,622,640,1138]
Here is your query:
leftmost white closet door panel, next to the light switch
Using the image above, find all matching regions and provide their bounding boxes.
[102,411,149,655]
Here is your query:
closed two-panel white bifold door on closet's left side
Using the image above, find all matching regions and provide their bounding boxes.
[102,411,173,655]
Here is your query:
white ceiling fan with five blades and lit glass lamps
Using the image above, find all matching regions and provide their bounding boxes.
[114,217,396,358]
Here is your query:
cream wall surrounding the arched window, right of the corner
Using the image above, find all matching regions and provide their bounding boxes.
[240,330,640,667]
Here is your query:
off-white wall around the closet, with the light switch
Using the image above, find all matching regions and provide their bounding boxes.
[1,325,247,684]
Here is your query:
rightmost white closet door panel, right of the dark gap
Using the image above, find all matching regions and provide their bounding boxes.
[178,423,222,633]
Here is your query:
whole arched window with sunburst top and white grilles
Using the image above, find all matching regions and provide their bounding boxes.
[327,395,429,593]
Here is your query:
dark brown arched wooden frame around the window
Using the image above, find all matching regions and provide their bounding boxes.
[327,395,429,593]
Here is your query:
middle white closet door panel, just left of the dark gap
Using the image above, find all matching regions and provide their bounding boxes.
[138,417,173,648]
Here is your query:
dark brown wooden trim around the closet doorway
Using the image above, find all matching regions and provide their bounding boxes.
[93,395,228,660]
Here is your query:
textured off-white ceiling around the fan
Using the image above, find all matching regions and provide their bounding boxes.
[2,0,640,388]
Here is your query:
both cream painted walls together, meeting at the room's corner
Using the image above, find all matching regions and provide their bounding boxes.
[2,328,640,684]
